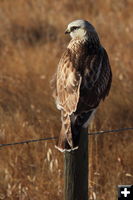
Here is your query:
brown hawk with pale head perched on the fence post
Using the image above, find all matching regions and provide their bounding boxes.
[53,20,112,152]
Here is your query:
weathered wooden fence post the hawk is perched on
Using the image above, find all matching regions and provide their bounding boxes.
[64,128,88,200]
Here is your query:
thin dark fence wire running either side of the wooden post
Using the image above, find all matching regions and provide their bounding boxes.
[0,128,133,148]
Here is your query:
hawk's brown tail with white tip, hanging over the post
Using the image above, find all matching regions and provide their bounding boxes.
[56,109,96,152]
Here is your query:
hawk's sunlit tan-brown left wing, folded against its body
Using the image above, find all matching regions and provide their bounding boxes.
[56,50,81,115]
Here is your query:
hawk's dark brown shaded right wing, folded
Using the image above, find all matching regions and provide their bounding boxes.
[77,47,112,113]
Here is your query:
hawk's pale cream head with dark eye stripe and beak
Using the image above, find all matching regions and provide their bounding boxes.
[65,19,96,39]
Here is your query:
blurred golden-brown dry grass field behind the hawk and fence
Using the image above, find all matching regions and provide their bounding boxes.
[0,0,133,200]
